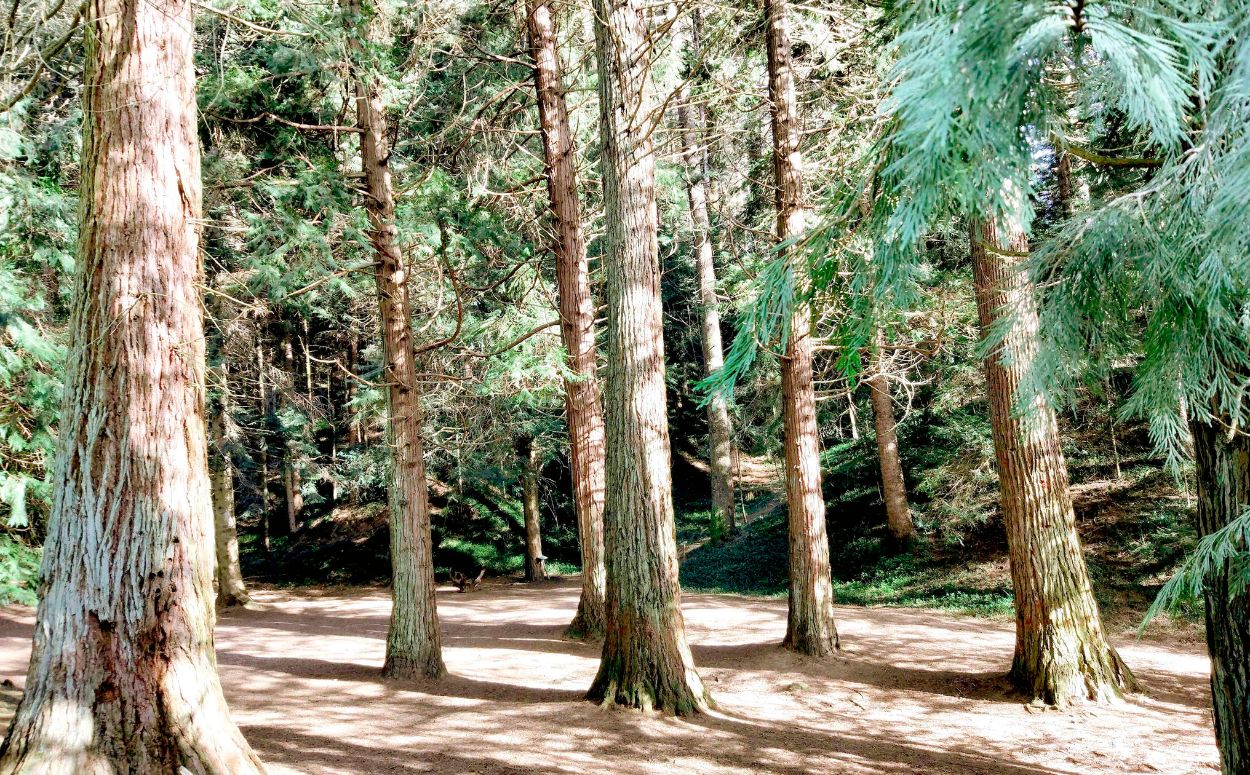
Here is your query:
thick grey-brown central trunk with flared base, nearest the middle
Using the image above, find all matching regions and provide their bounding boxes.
[588,0,710,714]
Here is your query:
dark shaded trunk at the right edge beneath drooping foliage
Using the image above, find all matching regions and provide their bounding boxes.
[1190,420,1250,775]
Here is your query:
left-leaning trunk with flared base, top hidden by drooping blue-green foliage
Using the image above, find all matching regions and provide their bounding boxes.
[970,216,1136,706]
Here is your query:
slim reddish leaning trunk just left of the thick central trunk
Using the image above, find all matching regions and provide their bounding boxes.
[528,0,606,638]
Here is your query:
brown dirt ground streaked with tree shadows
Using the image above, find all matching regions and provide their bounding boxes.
[0,580,1219,775]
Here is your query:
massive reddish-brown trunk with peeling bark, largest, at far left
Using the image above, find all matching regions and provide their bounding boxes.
[0,0,264,775]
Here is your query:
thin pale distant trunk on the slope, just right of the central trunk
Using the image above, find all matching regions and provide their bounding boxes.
[678,10,736,531]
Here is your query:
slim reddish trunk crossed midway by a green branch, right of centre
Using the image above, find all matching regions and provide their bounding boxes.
[764,0,838,656]
